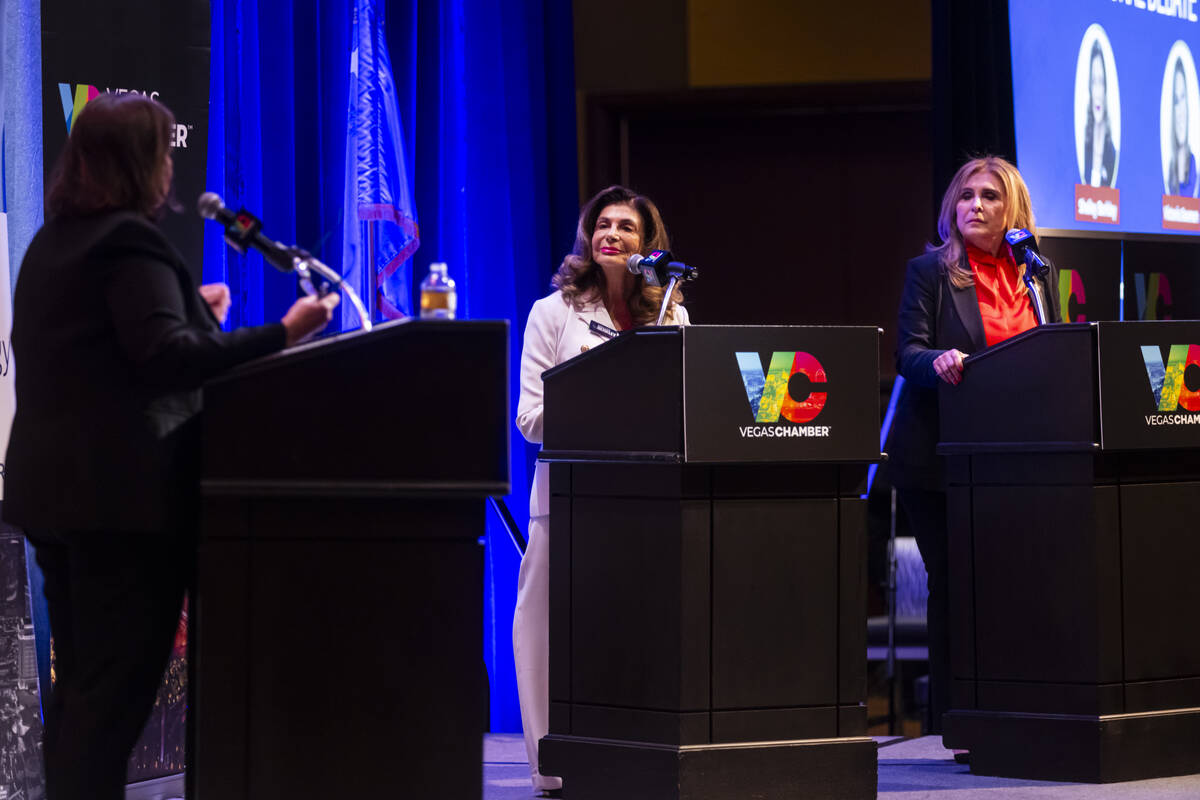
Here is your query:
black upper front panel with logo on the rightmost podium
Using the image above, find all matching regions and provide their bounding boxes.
[1097,321,1200,450]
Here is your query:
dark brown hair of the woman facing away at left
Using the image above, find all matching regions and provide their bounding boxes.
[46,92,179,218]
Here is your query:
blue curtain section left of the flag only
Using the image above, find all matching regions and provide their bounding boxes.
[204,0,352,327]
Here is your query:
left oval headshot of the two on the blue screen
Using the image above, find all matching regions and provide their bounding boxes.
[1075,24,1121,186]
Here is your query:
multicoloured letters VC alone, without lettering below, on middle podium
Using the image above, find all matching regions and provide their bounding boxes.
[737,351,826,423]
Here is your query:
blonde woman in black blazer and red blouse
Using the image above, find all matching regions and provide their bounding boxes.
[888,157,1060,733]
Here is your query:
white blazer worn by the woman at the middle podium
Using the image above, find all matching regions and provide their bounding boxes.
[517,291,690,517]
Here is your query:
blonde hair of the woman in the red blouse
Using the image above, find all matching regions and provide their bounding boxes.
[925,156,1038,289]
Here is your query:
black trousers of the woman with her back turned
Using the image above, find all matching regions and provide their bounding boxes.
[28,531,196,800]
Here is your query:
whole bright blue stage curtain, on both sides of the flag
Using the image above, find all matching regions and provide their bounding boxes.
[204,0,578,730]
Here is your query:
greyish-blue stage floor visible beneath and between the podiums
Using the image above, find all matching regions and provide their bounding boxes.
[482,734,1200,800]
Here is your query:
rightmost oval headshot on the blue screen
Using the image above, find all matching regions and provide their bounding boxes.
[1159,41,1200,197]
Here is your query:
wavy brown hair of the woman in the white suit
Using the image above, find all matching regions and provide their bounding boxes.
[551,186,683,325]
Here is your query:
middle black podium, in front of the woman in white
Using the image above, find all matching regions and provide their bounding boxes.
[540,325,880,800]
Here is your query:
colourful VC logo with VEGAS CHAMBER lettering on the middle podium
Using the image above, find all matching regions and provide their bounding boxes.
[736,350,829,439]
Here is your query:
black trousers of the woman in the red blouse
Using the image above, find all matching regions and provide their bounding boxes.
[896,489,950,733]
